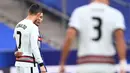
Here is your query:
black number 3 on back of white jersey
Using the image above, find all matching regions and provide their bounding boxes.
[92,17,102,41]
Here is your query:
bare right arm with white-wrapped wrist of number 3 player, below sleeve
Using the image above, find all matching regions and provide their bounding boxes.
[115,29,127,73]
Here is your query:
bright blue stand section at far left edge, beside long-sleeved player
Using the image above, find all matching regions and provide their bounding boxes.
[0,23,15,52]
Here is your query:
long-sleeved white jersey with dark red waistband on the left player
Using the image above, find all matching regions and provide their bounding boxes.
[13,19,43,67]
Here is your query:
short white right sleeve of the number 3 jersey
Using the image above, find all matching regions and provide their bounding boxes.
[114,12,126,30]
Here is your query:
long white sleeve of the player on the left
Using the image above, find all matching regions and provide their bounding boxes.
[30,29,43,64]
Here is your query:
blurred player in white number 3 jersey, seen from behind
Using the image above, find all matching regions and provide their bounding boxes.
[60,0,127,73]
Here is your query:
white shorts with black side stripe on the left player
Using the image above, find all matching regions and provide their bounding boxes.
[16,66,39,73]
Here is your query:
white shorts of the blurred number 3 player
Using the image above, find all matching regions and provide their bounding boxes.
[77,64,116,73]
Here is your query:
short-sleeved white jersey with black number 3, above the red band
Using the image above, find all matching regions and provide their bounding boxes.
[69,3,125,57]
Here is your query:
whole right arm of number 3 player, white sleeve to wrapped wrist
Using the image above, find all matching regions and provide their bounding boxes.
[114,12,127,71]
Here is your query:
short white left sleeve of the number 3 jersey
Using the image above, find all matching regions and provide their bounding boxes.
[69,9,80,31]
